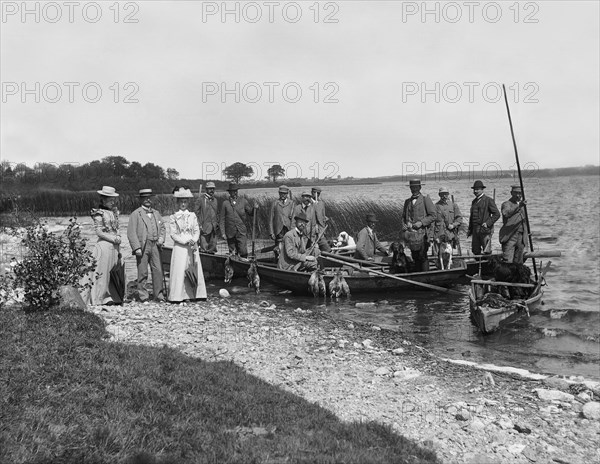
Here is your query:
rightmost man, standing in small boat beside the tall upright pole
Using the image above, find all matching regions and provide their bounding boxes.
[499,185,527,264]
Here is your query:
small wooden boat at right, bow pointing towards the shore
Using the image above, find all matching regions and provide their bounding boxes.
[469,262,550,334]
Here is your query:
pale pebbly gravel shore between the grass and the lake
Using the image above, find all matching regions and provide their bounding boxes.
[91,297,600,464]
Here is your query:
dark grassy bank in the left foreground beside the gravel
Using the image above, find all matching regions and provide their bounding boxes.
[0,308,438,464]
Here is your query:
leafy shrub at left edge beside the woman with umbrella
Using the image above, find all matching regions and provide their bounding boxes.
[13,218,96,311]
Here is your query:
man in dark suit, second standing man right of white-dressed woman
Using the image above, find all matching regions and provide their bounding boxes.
[219,183,258,258]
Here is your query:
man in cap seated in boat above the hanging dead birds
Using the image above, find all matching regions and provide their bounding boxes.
[277,211,320,272]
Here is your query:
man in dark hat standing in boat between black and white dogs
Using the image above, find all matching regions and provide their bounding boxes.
[402,179,436,272]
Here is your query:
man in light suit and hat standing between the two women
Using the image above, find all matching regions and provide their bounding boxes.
[127,189,166,301]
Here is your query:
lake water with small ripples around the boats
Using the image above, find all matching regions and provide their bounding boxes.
[31,176,600,379]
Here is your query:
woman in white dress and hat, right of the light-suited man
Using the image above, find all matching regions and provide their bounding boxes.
[169,187,206,303]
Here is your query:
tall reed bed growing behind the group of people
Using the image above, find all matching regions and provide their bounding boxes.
[0,190,402,240]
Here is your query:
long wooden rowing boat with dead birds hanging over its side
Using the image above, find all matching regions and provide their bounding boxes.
[231,258,467,294]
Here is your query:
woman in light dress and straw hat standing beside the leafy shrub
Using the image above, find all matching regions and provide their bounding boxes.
[82,186,122,305]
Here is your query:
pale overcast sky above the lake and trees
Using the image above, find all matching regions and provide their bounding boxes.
[0,0,600,180]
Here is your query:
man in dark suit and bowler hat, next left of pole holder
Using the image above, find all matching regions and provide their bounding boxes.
[467,180,500,255]
